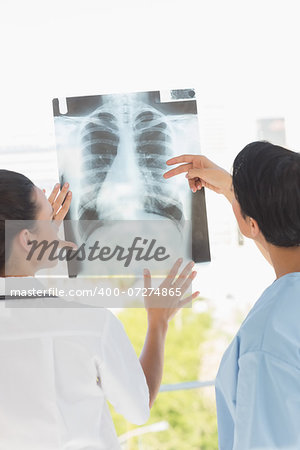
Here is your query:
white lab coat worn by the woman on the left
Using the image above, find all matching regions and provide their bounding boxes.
[0,284,149,450]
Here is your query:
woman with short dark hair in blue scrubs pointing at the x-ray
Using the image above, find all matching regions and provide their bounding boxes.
[165,141,300,450]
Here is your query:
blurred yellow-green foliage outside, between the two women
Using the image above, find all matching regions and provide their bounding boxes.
[111,308,218,450]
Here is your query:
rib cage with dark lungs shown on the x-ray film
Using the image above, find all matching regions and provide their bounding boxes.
[78,101,183,236]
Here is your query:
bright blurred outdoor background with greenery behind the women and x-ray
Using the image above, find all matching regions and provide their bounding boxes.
[0,0,300,450]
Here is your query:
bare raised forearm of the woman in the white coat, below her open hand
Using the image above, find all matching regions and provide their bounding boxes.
[140,323,168,408]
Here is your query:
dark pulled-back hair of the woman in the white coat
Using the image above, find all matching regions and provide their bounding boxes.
[0,169,38,275]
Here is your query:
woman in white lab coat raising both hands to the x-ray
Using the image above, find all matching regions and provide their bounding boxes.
[0,170,198,450]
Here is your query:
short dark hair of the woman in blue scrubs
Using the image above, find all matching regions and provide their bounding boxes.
[232,141,300,247]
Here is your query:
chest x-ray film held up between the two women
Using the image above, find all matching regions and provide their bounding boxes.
[53,89,210,275]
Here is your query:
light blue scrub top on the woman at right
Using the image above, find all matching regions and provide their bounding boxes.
[216,272,300,450]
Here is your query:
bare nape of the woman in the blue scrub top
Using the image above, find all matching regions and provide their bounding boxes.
[268,244,300,278]
